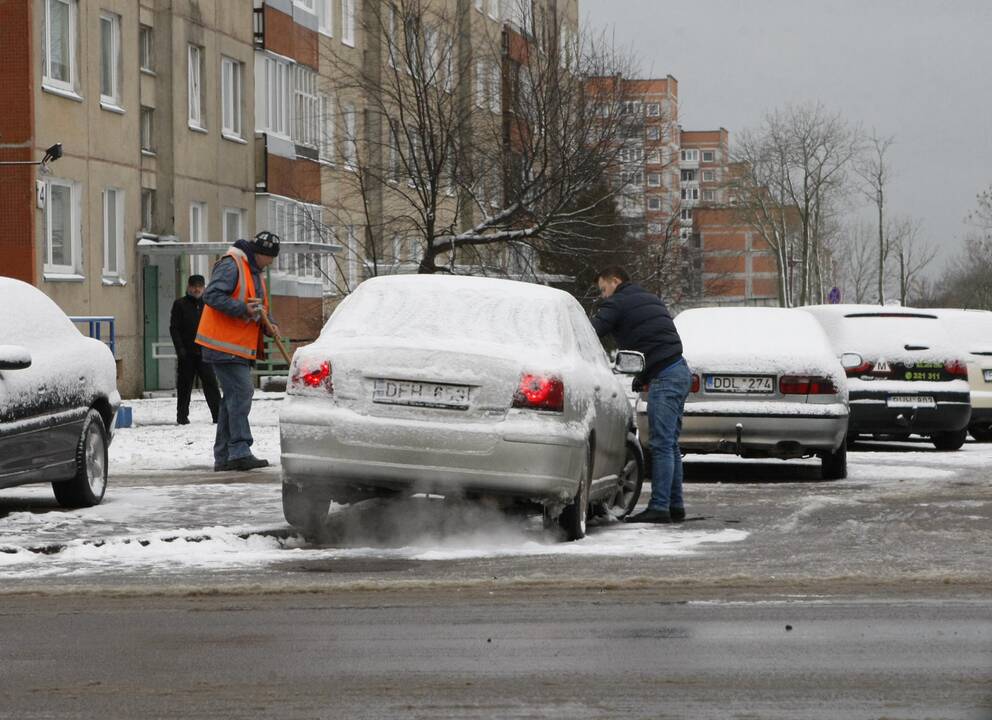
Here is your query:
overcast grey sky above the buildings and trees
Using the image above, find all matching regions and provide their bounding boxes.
[579,0,992,268]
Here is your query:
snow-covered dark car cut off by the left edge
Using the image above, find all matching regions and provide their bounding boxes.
[0,277,121,507]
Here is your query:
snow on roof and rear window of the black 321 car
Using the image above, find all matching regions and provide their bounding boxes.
[798,305,956,362]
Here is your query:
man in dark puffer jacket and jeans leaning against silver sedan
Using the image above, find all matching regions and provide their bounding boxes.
[592,267,692,523]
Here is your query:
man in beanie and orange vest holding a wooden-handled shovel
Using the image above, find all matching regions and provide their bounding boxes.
[196,231,279,472]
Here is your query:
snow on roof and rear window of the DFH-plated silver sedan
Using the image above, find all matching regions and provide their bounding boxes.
[321,275,576,352]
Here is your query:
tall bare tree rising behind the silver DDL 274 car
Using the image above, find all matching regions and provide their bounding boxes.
[731,103,859,306]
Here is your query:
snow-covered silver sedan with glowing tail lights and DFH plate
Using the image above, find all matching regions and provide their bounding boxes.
[279,275,643,539]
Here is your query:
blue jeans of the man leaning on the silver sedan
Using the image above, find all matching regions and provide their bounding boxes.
[648,358,692,510]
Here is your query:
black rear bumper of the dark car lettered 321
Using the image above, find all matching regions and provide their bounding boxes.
[850,391,971,435]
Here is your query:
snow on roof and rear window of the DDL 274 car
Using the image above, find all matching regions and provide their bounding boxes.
[675,307,840,373]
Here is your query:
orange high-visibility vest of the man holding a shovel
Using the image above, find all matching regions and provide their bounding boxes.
[196,247,269,360]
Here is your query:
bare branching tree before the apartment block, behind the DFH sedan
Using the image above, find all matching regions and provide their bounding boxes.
[318,0,656,282]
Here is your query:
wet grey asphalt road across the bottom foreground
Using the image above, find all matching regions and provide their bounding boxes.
[0,590,992,720]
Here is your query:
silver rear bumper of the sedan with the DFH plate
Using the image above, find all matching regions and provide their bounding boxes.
[279,400,586,502]
